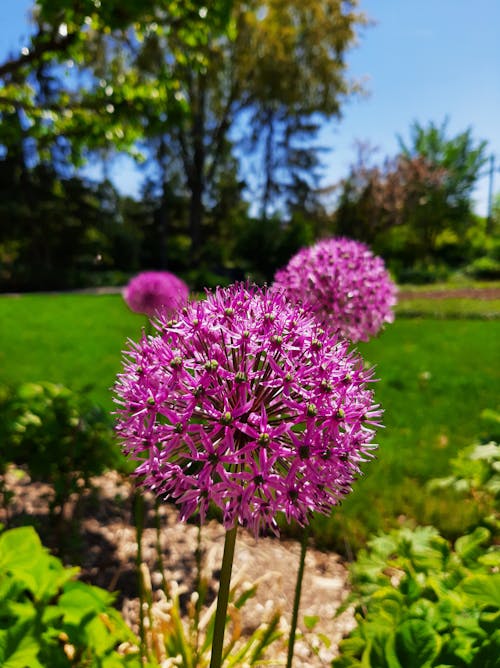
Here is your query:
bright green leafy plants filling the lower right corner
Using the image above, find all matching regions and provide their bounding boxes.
[332,442,500,668]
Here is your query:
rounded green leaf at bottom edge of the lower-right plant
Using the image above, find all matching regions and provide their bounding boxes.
[395,619,441,668]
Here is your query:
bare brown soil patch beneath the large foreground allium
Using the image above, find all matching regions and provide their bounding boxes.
[0,470,355,668]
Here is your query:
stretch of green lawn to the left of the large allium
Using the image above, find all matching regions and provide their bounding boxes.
[0,294,145,409]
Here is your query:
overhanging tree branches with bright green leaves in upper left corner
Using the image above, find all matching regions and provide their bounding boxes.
[0,0,231,163]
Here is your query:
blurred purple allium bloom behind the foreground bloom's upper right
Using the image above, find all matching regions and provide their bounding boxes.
[274,238,397,342]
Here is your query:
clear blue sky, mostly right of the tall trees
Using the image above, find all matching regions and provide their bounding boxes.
[0,0,500,215]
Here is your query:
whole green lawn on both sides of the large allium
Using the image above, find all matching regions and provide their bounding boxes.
[0,294,500,551]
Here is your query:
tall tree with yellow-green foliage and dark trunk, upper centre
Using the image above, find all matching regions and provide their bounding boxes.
[60,0,365,260]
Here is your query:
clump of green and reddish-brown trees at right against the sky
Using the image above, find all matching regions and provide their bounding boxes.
[335,122,486,272]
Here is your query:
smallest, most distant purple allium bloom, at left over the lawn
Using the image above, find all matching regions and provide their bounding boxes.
[123,271,189,316]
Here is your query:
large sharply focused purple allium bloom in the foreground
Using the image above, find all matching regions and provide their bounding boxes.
[116,285,382,533]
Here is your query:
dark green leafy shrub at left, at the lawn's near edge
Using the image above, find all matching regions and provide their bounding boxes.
[6,382,118,513]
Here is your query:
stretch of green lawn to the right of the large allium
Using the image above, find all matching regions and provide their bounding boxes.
[317,318,500,549]
